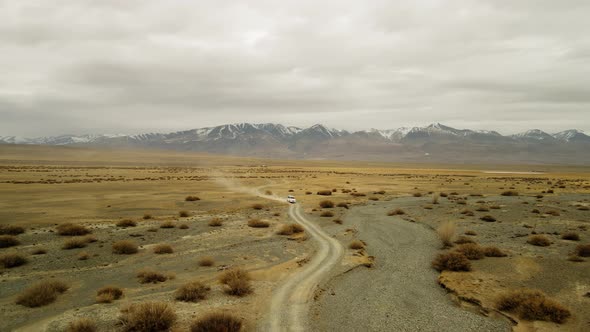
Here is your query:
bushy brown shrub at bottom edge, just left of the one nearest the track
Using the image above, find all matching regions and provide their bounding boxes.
[119,302,176,332]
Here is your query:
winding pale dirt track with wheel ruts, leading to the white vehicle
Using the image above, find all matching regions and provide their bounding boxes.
[264,204,344,331]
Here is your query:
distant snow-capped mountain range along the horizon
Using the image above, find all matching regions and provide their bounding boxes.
[0,123,590,165]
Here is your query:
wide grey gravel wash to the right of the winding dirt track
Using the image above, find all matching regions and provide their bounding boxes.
[311,203,510,331]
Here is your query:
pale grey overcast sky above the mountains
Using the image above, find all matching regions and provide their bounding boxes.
[0,0,590,136]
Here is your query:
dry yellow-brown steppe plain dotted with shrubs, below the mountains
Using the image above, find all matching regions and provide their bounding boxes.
[0,145,590,331]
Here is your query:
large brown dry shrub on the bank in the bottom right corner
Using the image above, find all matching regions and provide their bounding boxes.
[496,289,571,324]
